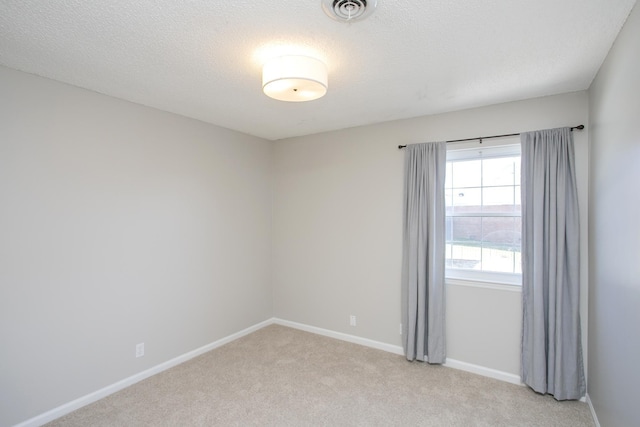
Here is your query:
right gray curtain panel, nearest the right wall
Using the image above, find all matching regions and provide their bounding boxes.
[521,128,585,400]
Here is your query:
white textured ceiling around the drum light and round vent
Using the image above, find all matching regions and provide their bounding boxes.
[0,0,635,139]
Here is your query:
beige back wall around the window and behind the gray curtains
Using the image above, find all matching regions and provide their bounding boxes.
[273,92,588,375]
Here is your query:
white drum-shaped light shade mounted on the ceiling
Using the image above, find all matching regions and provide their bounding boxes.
[262,56,328,102]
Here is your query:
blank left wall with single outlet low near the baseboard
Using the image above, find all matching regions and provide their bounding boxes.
[0,67,272,426]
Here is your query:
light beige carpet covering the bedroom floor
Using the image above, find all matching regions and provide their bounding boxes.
[47,325,594,427]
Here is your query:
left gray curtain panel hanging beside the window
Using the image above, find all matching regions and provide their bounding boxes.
[402,142,447,363]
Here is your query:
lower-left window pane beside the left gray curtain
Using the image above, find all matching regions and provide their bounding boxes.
[447,218,482,269]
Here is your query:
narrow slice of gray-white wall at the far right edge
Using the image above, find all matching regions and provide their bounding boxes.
[588,5,640,427]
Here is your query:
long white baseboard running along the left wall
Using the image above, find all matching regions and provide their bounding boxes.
[14,319,273,427]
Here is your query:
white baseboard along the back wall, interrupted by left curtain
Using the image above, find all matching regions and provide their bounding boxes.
[273,318,522,385]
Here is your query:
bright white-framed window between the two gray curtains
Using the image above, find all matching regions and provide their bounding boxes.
[445,141,522,284]
